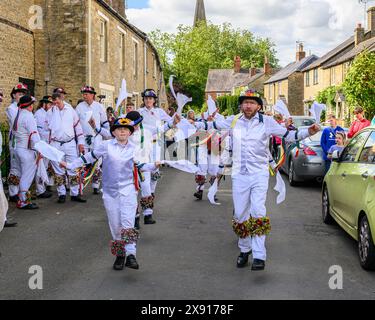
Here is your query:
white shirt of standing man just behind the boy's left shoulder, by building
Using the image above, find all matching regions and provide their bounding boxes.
[76,101,109,136]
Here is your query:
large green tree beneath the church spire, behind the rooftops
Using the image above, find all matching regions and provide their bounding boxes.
[149,22,278,109]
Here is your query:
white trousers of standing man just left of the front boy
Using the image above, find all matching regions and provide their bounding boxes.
[51,140,79,196]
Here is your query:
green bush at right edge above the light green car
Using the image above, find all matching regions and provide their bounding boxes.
[343,51,375,119]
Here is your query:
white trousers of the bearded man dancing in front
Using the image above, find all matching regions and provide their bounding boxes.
[232,171,269,261]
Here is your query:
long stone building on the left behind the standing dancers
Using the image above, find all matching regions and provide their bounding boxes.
[0,0,167,120]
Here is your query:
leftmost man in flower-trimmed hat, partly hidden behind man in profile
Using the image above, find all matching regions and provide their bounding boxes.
[5,83,29,202]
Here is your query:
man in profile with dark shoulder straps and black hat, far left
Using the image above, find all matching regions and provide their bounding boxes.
[12,95,40,210]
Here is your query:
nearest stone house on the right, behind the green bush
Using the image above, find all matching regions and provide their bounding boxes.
[302,6,375,125]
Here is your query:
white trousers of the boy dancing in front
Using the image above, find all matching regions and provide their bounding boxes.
[103,184,138,256]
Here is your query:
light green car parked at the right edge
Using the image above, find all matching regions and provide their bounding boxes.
[322,126,375,270]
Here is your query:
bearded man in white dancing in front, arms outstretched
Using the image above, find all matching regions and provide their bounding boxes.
[198,90,320,270]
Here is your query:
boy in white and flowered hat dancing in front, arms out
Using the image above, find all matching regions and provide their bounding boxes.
[61,118,160,270]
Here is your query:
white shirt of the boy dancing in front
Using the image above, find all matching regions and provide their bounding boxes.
[68,139,156,197]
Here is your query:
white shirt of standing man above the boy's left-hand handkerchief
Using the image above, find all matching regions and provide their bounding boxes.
[47,104,84,144]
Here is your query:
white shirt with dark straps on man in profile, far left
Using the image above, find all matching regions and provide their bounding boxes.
[13,110,40,149]
